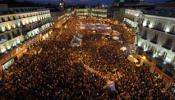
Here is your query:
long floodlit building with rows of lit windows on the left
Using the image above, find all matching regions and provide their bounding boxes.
[0,8,53,69]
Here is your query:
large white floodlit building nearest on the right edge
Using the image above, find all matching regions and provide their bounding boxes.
[137,10,175,81]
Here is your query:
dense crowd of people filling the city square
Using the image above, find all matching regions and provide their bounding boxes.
[0,17,174,100]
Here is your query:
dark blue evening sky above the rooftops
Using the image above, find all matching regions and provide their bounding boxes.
[17,0,167,4]
